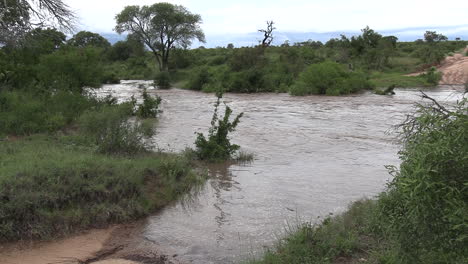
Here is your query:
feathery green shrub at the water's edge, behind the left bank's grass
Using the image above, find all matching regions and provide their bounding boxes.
[78,103,154,155]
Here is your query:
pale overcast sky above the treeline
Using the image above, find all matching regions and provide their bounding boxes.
[68,0,468,35]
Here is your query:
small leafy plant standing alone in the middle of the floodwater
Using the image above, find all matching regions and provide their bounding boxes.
[195,93,244,161]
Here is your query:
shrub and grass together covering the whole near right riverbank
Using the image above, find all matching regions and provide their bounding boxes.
[252,95,468,263]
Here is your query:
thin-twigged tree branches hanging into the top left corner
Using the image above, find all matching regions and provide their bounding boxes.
[0,0,76,44]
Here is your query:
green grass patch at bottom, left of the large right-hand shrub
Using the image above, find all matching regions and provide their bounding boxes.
[249,200,395,264]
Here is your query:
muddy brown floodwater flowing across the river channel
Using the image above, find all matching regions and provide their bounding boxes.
[93,81,462,263]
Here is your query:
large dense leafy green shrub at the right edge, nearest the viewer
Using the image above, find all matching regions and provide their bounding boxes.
[380,95,468,263]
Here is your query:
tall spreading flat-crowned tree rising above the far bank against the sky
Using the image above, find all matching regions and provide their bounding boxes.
[115,3,205,71]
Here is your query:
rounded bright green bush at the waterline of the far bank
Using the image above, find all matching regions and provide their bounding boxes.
[290,62,372,95]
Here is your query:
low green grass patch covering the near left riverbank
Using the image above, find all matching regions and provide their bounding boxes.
[0,135,204,241]
